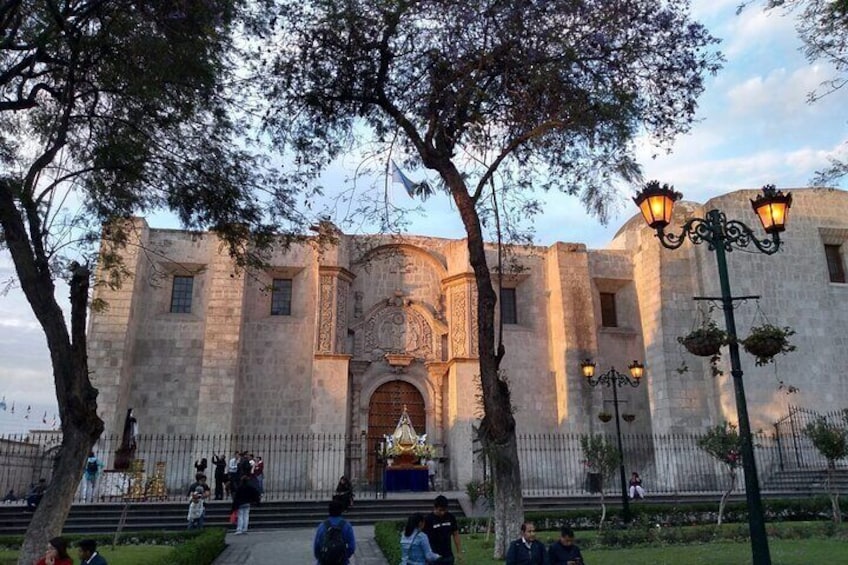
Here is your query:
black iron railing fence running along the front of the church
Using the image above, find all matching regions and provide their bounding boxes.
[0,408,845,501]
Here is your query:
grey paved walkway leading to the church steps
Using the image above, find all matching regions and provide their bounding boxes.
[214,526,388,565]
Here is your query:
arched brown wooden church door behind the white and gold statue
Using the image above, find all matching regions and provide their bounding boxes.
[368,380,427,482]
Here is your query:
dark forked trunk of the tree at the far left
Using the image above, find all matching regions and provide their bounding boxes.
[0,181,103,565]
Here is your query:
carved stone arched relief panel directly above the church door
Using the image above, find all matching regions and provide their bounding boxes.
[364,306,433,361]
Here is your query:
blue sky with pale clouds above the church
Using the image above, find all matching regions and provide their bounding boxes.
[0,0,848,435]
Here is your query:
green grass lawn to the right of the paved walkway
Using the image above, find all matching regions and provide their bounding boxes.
[460,532,848,565]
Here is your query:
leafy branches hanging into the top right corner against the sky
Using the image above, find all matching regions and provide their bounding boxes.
[738,0,848,182]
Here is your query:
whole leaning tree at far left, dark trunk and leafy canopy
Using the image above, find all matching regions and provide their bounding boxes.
[0,0,304,564]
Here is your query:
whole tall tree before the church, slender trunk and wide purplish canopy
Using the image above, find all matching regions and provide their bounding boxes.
[257,0,720,557]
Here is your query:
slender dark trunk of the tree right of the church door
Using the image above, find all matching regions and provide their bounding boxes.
[440,170,524,559]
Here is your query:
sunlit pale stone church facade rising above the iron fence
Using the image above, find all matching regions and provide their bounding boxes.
[89,189,848,485]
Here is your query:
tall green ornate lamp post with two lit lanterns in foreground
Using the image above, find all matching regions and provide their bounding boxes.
[633,181,792,565]
